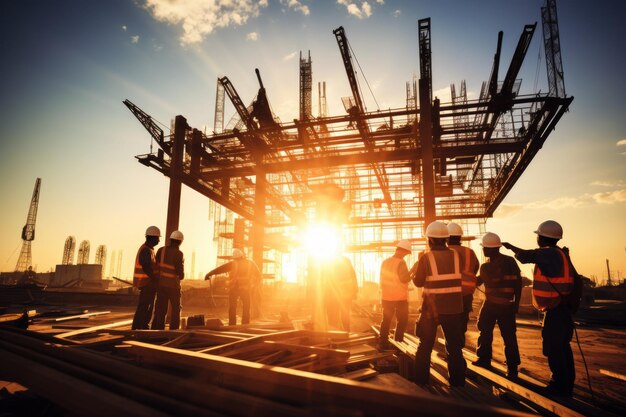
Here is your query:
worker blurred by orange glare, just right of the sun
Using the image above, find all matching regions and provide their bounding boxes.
[322,256,358,332]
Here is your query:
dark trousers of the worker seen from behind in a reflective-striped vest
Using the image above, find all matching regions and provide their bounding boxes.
[415,313,467,387]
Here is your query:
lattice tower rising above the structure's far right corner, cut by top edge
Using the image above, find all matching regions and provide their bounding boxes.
[541,0,565,98]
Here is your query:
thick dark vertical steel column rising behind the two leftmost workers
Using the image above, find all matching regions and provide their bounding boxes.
[165,116,187,244]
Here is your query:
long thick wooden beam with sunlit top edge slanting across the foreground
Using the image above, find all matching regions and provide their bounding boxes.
[128,342,528,417]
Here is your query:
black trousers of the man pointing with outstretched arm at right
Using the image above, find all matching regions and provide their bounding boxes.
[541,305,576,395]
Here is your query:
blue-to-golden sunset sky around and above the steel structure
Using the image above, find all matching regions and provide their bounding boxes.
[0,0,626,281]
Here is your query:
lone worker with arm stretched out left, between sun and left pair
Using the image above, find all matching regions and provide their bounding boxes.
[204,248,262,326]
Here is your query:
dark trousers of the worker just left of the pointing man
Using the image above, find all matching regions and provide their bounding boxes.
[477,301,520,369]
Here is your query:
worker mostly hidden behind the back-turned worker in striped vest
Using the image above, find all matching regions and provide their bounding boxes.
[448,223,479,332]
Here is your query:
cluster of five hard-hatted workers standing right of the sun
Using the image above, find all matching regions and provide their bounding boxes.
[378,220,575,397]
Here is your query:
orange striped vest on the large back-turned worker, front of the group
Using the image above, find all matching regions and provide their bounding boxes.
[423,251,463,313]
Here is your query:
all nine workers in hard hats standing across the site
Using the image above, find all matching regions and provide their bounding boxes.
[132,220,575,396]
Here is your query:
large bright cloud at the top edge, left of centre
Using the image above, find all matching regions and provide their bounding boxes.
[144,0,267,46]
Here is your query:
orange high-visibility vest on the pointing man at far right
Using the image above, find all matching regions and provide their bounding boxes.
[533,248,574,311]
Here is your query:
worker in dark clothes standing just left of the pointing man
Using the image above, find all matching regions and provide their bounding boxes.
[473,232,522,379]
